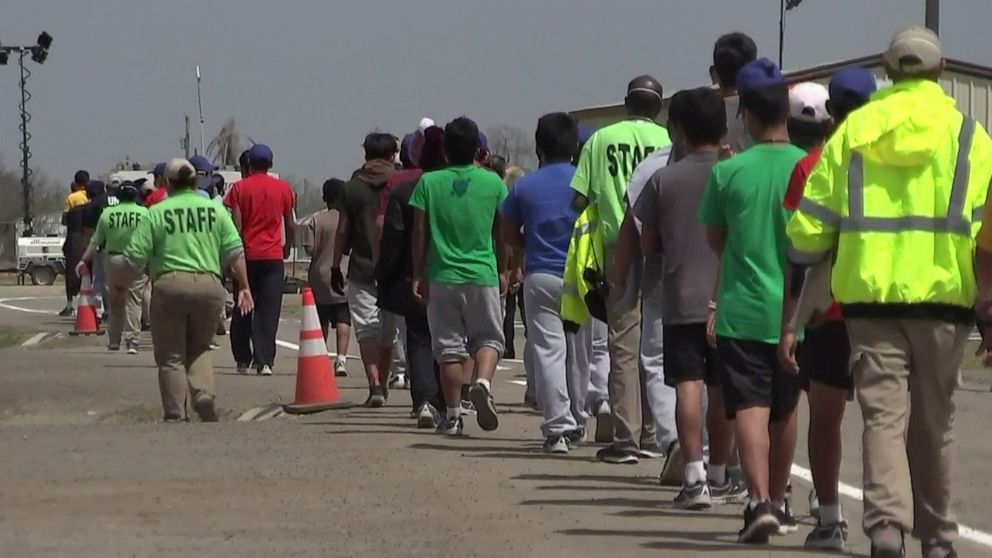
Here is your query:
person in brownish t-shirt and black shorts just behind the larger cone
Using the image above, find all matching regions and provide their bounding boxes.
[303,178,351,376]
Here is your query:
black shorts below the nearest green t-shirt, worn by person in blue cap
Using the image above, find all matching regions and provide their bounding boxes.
[716,337,800,422]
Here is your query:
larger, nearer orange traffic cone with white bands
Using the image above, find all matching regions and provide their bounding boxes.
[285,287,351,414]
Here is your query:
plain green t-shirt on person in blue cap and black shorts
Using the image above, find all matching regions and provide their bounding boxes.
[699,143,806,344]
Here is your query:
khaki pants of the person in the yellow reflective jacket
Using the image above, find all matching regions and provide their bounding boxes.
[847,319,970,540]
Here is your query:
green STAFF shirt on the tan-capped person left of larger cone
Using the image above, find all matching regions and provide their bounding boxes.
[124,190,244,279]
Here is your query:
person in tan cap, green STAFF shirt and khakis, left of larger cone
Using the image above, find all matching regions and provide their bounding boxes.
[124,159,254,422]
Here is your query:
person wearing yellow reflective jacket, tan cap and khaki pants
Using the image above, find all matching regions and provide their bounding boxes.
[788,27,992,558]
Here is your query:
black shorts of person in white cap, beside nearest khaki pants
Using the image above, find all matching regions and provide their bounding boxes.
[796,320,854,391]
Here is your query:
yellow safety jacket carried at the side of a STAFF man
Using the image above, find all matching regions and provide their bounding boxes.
[561,205,605,325]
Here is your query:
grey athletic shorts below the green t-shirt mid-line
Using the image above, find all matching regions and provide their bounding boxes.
[427,283,504,366]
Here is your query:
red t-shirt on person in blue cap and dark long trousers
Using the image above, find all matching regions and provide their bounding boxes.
[224,174,296,260]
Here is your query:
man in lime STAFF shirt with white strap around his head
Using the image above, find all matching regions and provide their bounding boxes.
[572,76,671,463]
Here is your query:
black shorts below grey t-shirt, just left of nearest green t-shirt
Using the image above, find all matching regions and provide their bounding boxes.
[662,323,720,387]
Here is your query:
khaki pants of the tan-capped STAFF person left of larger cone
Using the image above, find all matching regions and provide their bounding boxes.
[152,272,224,419]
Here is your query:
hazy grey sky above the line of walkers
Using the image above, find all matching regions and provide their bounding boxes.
[0,0,992,190]
